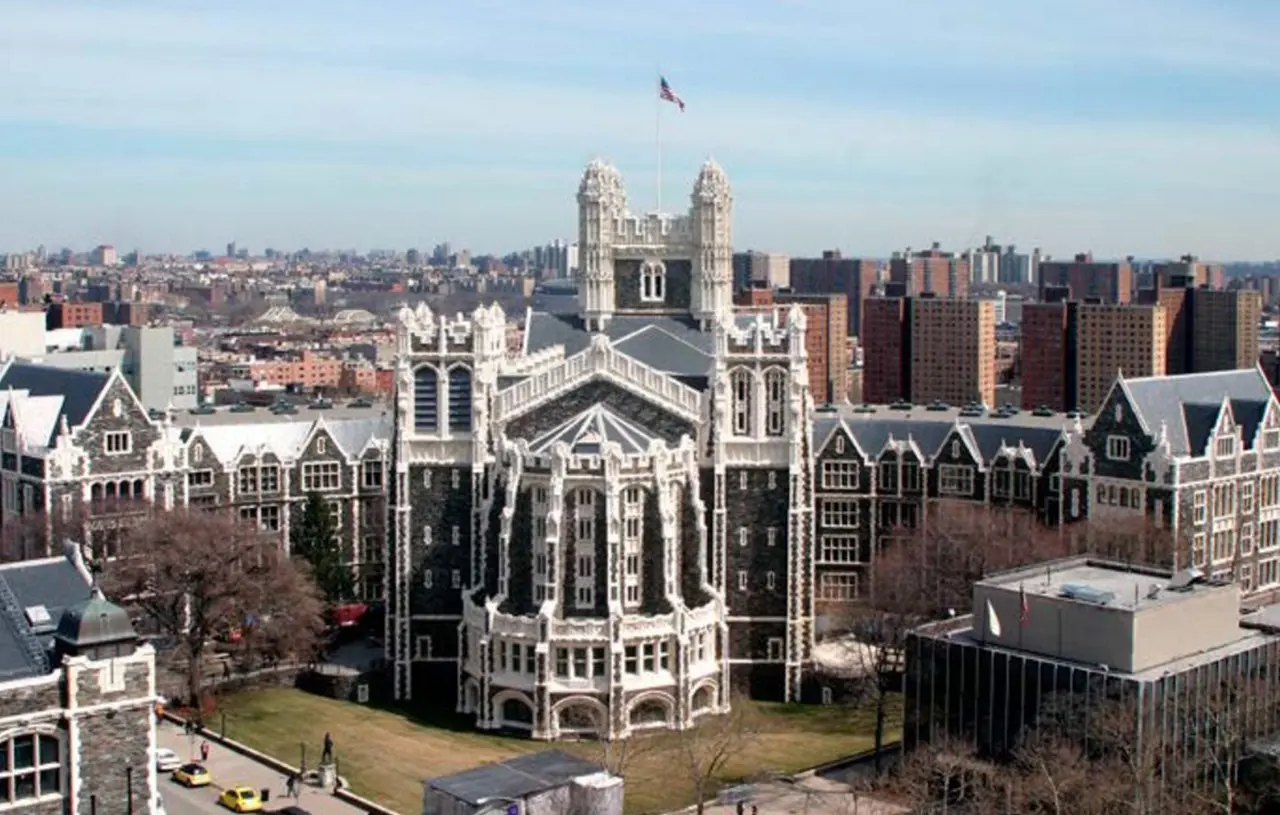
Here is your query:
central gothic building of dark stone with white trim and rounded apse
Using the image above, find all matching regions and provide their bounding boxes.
[387,161,813,738]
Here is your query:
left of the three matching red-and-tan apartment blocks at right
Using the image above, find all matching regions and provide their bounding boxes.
[863,296,996,406]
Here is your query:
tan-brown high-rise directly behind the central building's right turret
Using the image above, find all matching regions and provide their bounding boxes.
[733,283,849,404]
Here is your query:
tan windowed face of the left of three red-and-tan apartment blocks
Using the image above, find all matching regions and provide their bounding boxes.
[908,297,996,407]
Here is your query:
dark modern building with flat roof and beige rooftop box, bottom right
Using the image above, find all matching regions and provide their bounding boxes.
[902,558,1280,798]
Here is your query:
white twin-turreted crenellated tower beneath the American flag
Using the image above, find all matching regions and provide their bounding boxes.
[577,160,733,331]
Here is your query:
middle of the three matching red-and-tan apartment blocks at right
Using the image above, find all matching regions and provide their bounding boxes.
[1021,301,1167,413]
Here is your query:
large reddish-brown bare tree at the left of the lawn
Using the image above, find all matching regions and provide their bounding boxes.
[104,509,324,705]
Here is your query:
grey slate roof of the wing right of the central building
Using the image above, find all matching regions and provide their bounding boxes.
[813,406,1073,466]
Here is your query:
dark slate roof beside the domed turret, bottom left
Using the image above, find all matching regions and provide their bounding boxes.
[0,558,90,681]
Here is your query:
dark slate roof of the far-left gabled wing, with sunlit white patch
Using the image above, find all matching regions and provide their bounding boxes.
[0,361,111,447]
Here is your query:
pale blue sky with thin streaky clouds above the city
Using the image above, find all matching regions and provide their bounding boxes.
[0,0,1280,258]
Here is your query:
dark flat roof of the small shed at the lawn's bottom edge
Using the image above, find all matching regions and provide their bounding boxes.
[426,750,604,806]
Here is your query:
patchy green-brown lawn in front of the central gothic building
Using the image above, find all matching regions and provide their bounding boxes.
[211,688,899,815]
